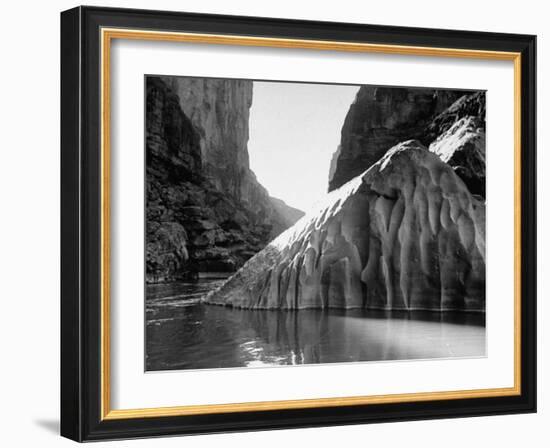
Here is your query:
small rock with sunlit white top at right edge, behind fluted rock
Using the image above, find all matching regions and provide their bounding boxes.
[429,116,485,198]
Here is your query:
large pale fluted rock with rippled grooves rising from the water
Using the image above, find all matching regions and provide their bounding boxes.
[205,141,485,310]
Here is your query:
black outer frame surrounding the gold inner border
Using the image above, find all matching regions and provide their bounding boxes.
[61,6,537,441]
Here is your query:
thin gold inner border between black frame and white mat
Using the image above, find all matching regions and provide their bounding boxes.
[100,28,521,420]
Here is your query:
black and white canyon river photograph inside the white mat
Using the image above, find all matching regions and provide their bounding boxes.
[144,75,486,371]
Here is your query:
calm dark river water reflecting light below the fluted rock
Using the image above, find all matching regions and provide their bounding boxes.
[146,279,486,371]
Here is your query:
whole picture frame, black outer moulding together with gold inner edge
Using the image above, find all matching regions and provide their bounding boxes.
[61,6,537,441]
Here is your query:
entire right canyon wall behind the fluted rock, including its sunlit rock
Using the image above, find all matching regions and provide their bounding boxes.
[329,86,485,198]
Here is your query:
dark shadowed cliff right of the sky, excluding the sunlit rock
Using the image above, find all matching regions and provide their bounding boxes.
[329,86,468,191]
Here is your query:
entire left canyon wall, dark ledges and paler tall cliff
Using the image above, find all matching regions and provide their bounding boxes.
[146,77,303,282]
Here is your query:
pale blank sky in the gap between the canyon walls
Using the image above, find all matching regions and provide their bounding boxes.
[248,81,359,211]
